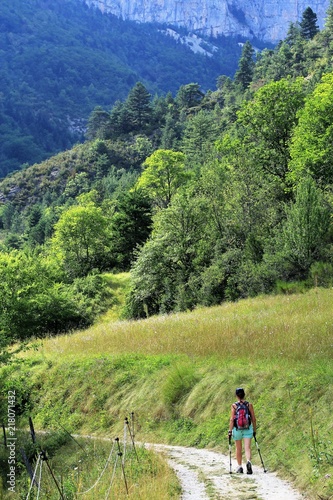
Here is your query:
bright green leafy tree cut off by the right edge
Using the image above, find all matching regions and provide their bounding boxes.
[289,74,333,186]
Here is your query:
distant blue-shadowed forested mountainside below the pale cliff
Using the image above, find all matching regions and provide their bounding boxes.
[0,0,246,177]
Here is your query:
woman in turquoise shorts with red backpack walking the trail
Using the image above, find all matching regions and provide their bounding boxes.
[228,387,256,474]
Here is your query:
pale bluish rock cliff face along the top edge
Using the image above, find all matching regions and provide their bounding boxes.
[83,0,329,42]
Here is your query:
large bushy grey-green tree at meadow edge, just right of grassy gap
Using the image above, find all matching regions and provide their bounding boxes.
[123,193,209,317]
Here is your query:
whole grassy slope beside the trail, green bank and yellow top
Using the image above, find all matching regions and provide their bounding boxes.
[0,289,333,499]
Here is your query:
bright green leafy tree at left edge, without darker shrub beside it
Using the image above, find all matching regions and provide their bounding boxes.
[0,251,78,344]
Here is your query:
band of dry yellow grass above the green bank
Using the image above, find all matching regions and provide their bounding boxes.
[33,289,333,360]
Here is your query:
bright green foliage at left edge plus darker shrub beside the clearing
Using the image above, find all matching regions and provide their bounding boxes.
[0,251,110,347]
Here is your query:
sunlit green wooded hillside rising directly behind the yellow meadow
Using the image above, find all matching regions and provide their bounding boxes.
[0,4,333,362]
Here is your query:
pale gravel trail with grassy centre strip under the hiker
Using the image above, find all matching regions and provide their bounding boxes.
[146,444,306,500]
